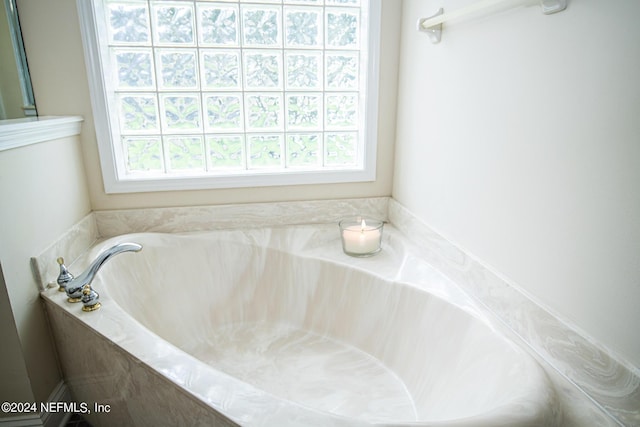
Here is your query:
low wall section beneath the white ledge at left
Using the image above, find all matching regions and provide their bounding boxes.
[0,136,89,404]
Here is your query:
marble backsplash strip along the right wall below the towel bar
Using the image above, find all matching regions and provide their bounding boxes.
[389,200,640,426]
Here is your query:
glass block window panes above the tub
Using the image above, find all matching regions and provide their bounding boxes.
[78,0,380,191]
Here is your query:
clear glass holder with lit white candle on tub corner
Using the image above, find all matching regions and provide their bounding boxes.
[338,216,384,257]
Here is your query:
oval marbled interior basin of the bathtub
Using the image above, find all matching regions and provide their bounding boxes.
[87,232,553,426]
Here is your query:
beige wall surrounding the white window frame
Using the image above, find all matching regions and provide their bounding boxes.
[18,0,401,210]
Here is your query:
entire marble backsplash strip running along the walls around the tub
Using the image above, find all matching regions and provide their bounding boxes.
[32,198,640,426]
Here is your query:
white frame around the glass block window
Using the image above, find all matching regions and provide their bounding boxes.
[76,0,382,193]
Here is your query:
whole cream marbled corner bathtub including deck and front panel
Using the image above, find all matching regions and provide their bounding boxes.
[43,225,559,427]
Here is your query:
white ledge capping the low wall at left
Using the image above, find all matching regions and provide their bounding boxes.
[0,116,83,151]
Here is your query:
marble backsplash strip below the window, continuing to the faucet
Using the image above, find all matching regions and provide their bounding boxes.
[31,197,389,291]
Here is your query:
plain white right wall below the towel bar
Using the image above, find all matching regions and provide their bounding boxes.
[393,0,640,367]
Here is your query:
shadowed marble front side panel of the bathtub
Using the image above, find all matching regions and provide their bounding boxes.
[48,308,238,427]
